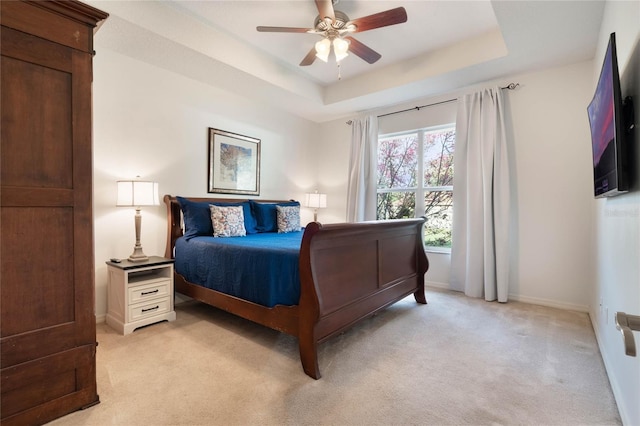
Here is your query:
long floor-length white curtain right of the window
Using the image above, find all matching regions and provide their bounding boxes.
[451,87,510,302]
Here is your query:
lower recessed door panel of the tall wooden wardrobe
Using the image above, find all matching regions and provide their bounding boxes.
[0,207,75,338]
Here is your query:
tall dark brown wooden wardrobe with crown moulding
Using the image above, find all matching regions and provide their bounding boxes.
[0,0,107,426]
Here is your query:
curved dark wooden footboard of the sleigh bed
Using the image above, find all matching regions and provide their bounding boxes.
[298,219,429,379]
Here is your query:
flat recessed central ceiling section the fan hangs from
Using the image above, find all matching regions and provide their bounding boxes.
[172,0,498,86]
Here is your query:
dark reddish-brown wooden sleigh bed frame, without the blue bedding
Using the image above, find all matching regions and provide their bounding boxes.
[164,195,429,379]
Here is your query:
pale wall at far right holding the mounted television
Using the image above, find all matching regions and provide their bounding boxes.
[590,1,640,425]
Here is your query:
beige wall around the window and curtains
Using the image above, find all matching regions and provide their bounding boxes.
[317,61,594,312]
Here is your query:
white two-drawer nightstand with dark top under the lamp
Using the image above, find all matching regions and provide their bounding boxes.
[107,256,176,334]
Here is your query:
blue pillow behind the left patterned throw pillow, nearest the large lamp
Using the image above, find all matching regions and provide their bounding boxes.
[176,197,258,239]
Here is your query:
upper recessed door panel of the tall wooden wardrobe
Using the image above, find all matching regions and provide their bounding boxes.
[1,57,73,188]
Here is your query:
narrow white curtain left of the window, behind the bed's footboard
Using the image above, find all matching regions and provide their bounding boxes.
[347,115,378,222]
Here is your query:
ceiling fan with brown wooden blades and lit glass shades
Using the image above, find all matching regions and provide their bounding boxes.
[256,0,407,66]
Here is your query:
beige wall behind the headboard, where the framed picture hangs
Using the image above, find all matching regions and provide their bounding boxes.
[93,47,318,320]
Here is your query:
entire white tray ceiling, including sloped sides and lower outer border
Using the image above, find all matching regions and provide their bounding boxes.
[87,0,604,122]
